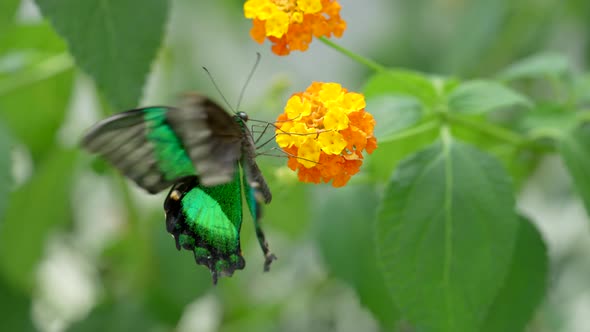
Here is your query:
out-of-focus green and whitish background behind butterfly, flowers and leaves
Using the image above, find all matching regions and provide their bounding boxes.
[0,0,590,332]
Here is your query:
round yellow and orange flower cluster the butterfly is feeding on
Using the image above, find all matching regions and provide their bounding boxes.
[275,82,377,187]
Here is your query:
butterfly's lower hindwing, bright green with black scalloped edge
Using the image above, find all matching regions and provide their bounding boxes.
[164,172,246,284]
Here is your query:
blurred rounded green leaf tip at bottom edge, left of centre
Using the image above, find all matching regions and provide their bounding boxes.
[67,301,161,332]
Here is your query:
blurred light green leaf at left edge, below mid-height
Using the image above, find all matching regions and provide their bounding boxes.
[0,151,76,290]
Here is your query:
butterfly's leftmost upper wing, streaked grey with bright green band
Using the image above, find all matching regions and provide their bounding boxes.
[82,106,196,193]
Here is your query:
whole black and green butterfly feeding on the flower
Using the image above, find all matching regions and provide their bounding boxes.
[82,94,276,284]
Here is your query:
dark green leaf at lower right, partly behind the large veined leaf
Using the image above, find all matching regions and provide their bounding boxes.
[482,217,548,332]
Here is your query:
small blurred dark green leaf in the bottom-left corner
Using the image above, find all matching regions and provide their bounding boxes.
[0,276,36,332]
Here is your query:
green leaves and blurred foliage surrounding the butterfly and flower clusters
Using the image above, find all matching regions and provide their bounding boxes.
[0,0,590,331]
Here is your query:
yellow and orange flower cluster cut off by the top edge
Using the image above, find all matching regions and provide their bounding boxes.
[244,0,346,55]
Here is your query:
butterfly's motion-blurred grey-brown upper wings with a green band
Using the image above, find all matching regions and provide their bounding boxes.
[83,94,247,193]
